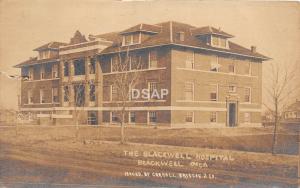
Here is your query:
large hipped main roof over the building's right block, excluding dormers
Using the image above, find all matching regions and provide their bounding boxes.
[100,21,270,60]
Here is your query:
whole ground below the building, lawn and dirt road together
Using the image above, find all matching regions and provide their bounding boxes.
[0,126,298,187]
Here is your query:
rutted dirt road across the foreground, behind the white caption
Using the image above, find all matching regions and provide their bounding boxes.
[0,140,297,187]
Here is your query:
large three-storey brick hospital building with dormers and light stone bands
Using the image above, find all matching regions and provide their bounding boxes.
[15,21,269,127]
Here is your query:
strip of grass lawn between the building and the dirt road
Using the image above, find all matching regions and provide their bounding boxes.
[4,126,299,155]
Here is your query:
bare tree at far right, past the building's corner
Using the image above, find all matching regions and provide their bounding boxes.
[263,63,299,154]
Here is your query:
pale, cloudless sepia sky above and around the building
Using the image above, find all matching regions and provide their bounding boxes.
[0,0,300,108]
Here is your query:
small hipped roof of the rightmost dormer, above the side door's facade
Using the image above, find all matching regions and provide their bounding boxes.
[191,26,234,38]
